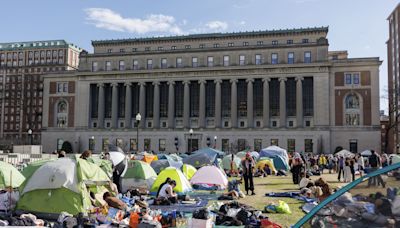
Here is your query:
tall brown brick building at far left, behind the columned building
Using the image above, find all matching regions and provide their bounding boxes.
[0,40,81,147]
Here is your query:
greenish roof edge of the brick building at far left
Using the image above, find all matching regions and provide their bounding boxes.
[0,40,82,51]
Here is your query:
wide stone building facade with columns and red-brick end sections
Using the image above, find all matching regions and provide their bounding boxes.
[42,27,381,153]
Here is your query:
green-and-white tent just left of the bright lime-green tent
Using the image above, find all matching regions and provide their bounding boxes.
[121,160,157,192]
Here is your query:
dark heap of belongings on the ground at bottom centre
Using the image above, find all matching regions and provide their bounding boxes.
[209,201,265,227]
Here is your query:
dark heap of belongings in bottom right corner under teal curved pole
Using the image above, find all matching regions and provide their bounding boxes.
[310,188,400,227]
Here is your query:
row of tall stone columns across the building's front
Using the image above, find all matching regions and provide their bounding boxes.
[98,77,303,128]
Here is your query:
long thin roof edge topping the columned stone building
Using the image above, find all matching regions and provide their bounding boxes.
[92,27,329,46]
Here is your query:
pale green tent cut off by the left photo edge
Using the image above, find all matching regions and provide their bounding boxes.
[0,161,25,189]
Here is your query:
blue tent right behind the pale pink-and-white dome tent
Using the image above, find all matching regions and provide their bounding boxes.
[183,148,222,168]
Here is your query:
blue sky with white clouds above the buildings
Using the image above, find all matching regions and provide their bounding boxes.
[0,0,398,110]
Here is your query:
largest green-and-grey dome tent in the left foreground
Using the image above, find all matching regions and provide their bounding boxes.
[17,158,110,218]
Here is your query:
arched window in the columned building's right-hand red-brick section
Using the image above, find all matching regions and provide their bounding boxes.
[344,94,361,126]
